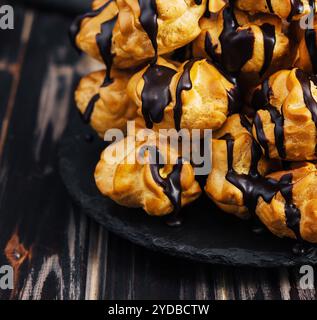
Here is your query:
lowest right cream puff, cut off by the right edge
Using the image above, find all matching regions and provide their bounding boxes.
[256,163,317,242]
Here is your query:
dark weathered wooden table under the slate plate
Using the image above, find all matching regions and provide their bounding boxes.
[0,1,316,299]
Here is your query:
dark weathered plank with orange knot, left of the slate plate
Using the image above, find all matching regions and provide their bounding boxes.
[0,6,88,299]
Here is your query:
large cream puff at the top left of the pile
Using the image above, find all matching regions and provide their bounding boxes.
[72,0,206,69]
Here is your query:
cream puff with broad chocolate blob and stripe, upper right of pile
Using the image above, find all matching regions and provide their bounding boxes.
[193,6,289,78]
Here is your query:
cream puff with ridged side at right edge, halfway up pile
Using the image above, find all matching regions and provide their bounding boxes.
[252,68,317,161]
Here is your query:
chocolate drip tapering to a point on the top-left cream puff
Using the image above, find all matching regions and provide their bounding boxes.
[139,0,158,62]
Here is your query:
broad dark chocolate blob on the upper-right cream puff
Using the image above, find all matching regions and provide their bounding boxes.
[217,5,255,73]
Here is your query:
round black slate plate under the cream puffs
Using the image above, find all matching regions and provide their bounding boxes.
[59,117,317,267]
